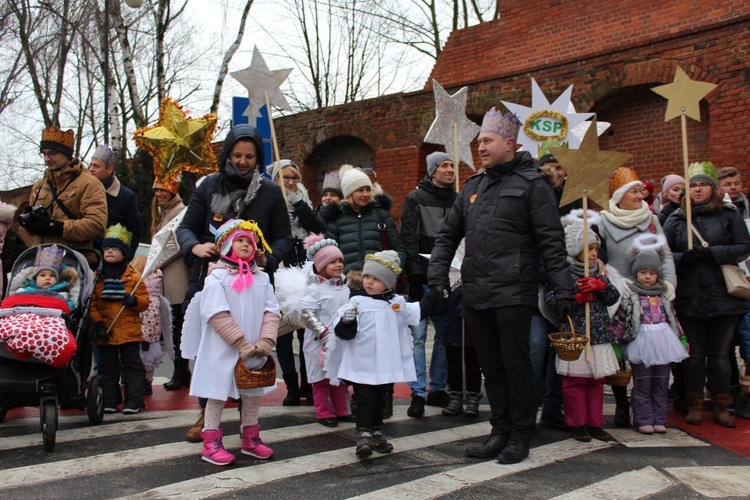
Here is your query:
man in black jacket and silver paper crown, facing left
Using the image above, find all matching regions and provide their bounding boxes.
[428,108,575,464]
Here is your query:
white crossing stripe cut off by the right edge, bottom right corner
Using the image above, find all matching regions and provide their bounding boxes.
[664,465,750,498]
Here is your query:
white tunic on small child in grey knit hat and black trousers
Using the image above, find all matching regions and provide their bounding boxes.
[326,295,420,385]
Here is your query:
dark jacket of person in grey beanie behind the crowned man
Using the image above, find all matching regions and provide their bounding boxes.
[401,178,458,282]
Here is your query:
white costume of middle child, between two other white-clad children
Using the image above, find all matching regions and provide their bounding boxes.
[300,277,350,384]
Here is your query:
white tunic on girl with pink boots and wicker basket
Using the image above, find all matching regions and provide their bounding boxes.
[182,269,281,401]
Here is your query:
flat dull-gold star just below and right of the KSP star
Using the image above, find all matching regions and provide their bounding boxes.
[549,118,633,207]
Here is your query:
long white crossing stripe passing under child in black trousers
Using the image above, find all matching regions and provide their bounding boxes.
[125,422,489,499]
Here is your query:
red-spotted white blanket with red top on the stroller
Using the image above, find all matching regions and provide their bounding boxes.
[0,294,77,368]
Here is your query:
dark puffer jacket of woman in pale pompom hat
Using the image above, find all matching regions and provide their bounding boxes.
[321,195,406,274]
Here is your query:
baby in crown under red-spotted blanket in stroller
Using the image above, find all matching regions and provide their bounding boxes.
[0,245,80,368]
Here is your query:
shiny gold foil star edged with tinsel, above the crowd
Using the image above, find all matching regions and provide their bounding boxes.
[133,97,218,184]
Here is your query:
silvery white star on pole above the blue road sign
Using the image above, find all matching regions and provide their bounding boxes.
[232,47,292,121]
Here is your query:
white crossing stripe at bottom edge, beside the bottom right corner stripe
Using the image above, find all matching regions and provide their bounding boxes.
[553,466,674,500]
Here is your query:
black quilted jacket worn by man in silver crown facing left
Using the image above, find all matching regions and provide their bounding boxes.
[428,152,575,309]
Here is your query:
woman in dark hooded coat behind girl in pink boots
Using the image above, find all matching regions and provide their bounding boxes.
[176,125,292,442]
